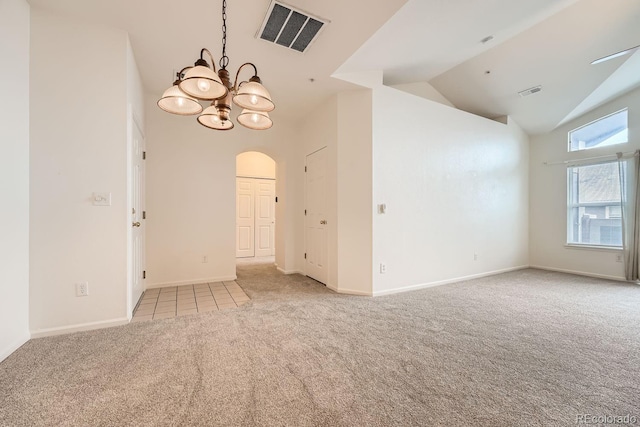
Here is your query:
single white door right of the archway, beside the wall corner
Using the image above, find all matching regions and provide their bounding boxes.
[305,148,328,284]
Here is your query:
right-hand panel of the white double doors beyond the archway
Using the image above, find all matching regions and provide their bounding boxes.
[254,179,276,257]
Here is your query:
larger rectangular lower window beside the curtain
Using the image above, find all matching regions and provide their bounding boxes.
[567,162,624,247]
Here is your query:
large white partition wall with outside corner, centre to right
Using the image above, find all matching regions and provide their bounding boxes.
[300,85,529,295]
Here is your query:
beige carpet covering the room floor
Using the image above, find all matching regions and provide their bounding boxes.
[0,264,640,426]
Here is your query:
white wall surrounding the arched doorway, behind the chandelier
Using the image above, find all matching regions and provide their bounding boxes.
[146,96,303,287]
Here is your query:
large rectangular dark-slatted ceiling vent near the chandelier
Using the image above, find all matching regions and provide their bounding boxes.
[257,1,329,52]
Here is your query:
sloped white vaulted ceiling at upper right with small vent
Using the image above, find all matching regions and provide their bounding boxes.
[339,0,640,134]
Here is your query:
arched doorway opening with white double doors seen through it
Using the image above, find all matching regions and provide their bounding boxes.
[236,151,276,259]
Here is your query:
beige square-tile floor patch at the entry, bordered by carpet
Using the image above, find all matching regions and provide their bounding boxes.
[133,281,250,322]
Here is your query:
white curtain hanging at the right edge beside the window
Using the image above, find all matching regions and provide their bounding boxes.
[618,151,640,282]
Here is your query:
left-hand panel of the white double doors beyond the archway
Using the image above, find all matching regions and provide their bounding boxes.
[236,178,255,258]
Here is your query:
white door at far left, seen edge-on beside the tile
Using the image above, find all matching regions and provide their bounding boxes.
[130,121,145,310]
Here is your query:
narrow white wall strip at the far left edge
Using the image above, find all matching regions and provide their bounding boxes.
[0,0,30,361]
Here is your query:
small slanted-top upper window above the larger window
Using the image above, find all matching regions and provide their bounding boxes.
[569,109,629,151]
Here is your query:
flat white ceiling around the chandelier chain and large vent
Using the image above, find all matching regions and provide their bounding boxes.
[28,0,406,124]
